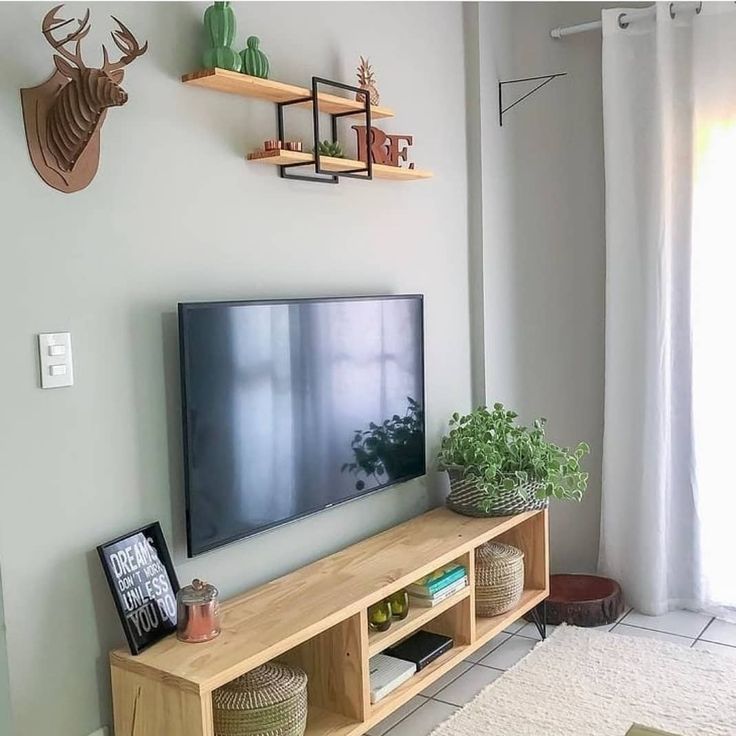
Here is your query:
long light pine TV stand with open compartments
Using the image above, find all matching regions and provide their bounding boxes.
[110,509,549,736]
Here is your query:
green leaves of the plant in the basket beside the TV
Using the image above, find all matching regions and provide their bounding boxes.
[438,404,590,506]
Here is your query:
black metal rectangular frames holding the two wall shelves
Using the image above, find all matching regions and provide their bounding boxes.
[276,77,373,184]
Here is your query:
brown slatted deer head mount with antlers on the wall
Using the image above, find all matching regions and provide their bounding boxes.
[20,5,148,192]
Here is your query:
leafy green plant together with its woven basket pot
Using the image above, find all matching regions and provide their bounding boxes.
[438,404,590,516]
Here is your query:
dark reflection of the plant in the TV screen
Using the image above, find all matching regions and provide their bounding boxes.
[342,396,424,491]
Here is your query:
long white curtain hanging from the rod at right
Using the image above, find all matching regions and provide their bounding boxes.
[600,2,736,618]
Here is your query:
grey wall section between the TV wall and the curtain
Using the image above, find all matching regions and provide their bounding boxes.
[471,2,605,572]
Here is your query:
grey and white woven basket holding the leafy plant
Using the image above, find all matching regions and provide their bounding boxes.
[446,465,547,516]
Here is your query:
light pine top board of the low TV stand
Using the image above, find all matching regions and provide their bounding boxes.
[111,508,546,692]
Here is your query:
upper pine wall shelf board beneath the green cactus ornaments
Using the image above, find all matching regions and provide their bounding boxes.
[181,69,394,118]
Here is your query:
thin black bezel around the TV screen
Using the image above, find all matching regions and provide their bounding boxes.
[178,294,427,559]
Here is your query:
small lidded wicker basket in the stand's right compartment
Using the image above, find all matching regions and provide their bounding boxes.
[475,542,524,617]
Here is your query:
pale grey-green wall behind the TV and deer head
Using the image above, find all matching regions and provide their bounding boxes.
[0,3,470,736]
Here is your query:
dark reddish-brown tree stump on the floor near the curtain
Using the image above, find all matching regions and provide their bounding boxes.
[530,575,624,626]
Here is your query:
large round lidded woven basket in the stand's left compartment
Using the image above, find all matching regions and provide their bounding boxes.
[212,662,307,736]
